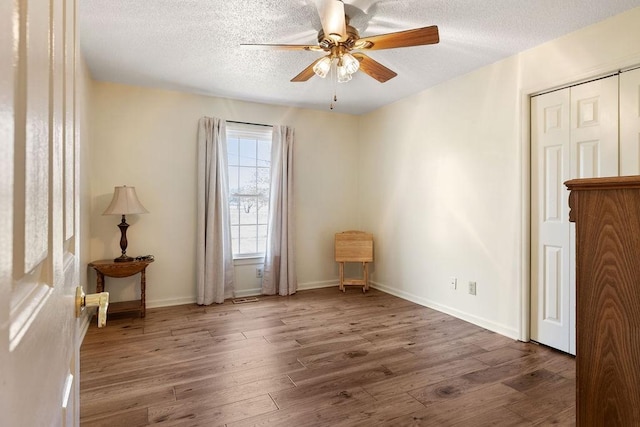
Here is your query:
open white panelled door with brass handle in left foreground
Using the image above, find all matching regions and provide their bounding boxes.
[0,0,80,426]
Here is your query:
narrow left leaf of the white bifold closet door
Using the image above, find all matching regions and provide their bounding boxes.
[531,89,571,351]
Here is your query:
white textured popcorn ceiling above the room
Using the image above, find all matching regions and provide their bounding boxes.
[79,0,640,114]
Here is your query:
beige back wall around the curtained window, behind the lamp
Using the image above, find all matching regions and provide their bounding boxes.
[88,82,358,307]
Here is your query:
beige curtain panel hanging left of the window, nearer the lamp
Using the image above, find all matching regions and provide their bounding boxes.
[196,117,233,305]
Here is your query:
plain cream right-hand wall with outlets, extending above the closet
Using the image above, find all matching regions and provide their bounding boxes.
[359,8,640,338]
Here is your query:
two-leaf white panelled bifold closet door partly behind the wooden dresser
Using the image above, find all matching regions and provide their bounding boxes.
[531,76,618,354]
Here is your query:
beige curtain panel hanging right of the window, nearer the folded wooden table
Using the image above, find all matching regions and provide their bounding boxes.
[262,126,298,296]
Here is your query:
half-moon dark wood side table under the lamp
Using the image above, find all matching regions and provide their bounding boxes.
[89,259,153,317]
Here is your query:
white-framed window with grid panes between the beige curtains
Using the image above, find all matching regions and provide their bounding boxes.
[227,122,272,258]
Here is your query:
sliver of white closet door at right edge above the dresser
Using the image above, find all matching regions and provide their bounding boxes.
[620,69,640,175]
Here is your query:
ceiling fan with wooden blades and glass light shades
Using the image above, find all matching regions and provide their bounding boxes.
[242,0,440,83]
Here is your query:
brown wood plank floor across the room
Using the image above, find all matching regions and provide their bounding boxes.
[80,288,575,427]
